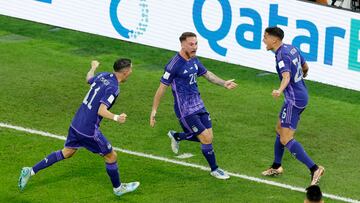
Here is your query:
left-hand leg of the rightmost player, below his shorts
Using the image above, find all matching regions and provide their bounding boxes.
[262,120,285,176]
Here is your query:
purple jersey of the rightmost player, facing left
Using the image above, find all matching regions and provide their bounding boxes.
[275,44,308,108]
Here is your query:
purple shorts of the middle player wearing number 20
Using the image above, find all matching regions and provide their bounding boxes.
[179,112,212,138]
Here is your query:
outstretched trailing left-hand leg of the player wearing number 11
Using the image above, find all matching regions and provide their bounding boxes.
[18,127,79,190]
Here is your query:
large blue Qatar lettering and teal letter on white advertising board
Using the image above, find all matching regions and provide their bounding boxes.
[192,0,360,72]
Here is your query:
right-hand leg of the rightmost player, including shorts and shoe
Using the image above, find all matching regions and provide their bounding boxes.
[280,105,324,184]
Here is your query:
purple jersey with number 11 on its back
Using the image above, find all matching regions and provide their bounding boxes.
[71,73,120,136]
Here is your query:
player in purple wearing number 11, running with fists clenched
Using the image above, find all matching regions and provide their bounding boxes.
[19,59,140,196]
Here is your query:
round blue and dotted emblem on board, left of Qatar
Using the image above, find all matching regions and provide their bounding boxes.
[110,0,149,39]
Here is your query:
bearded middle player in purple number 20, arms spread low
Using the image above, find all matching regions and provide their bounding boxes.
[150,32,237,179]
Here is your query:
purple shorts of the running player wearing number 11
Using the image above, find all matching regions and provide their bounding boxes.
[64,127,112,156]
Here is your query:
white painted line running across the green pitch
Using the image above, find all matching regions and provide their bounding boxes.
[0,122,360,203]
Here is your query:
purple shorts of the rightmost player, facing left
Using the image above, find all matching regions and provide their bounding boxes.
[279,103,305,130]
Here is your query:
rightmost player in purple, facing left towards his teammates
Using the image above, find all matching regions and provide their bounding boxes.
[262,27,325,185]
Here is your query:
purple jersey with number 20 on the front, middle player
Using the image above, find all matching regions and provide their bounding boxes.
[160,53,207,118]
